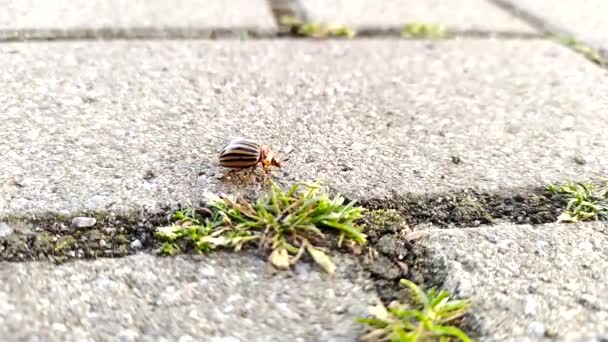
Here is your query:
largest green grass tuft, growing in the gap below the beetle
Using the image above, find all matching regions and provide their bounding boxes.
[156,182,367,273]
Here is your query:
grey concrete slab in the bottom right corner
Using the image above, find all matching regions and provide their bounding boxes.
[415,223,608,341]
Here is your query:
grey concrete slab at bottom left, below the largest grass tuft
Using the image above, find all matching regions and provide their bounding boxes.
[0,253,376,342]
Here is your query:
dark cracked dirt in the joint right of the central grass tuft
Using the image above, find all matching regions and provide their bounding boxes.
[354,188,565,304]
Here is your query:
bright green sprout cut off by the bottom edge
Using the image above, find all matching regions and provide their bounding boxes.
[357,279,470,342]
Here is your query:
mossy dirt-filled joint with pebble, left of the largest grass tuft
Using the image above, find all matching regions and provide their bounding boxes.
[0,213,168,262]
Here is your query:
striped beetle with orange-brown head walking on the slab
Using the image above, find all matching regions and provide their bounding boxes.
[219,138,281,169]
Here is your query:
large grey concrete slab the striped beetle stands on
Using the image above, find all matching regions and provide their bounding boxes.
[0,39,608,215]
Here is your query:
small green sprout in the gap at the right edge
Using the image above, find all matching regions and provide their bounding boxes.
[547,180,608,222]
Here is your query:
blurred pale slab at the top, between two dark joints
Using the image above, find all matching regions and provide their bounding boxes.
[300,0,535,33]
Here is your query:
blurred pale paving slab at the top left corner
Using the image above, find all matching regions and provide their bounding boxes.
[0,0,277,39]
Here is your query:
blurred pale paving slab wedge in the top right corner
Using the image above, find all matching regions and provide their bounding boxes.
[497,0,608,58]
